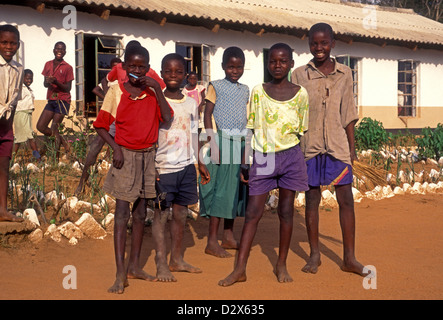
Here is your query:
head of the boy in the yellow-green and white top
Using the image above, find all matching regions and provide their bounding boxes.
[268,43,294,80]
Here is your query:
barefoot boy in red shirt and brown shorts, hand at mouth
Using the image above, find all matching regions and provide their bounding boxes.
[93,46,173,293]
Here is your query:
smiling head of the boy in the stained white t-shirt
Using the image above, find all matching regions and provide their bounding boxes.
[160,53,186,89]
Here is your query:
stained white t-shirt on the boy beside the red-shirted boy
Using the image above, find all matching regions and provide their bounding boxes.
[155,96,198,174]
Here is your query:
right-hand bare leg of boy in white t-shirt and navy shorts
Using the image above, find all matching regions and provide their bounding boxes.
[169,204,202,273]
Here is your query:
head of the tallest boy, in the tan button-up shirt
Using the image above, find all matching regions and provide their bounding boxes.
[309,22,335,62]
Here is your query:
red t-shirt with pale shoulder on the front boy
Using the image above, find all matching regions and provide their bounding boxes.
[93,82,174,150]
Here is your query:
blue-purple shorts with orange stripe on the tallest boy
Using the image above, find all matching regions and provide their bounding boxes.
[306,154,353,187]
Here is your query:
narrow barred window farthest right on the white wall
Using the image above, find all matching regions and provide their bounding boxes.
[398,60,417,117]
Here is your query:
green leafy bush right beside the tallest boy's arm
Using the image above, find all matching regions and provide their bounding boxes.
[354,117,388,151]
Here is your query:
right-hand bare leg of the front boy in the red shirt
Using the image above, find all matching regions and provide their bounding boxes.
[128,198,155,281]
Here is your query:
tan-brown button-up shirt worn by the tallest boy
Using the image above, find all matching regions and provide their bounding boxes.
[292,60,358,164]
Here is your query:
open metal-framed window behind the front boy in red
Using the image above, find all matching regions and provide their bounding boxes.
[75,32,123,118]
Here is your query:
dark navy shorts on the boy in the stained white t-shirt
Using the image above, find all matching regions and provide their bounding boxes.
[155,164,198,210]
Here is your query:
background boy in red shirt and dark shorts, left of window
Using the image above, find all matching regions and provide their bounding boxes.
[37,41,74,159]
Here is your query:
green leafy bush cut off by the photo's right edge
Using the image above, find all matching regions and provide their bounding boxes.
[416,123,443,160]
